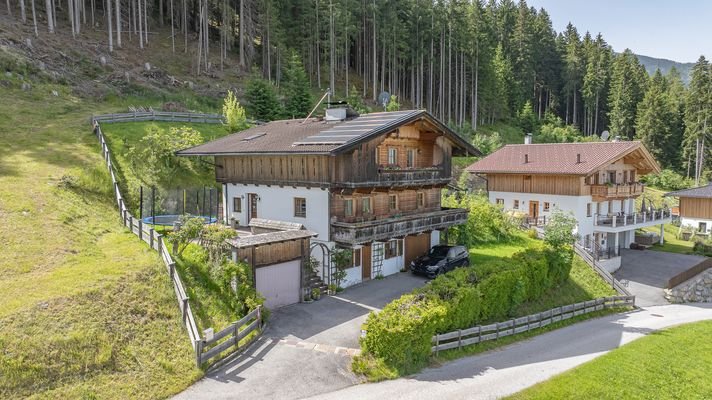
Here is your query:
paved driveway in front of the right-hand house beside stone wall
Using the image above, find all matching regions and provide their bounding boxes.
[613,250,705,307]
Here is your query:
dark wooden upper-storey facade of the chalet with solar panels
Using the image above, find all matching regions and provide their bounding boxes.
[215,123,452,188]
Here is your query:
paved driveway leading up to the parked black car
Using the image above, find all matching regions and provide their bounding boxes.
[175,273,425,399]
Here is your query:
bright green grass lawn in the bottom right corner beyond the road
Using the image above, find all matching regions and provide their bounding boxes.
[511,321,712,399]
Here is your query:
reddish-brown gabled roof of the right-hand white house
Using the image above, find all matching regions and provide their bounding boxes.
[467,142,660,175]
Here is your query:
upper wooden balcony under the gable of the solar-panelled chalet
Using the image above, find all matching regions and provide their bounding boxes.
[337,167,450,188]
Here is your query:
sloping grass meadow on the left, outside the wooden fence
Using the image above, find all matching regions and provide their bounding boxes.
[0,78,202,399]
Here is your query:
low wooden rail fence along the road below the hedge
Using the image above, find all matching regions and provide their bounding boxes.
[431,296,635,355]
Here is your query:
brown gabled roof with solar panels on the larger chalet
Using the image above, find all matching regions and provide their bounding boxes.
[176,110,481,156]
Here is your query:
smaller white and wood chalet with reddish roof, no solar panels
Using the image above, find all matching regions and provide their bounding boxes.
[467,136,670,271]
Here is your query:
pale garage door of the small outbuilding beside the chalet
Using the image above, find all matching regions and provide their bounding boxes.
[255,260,300,309]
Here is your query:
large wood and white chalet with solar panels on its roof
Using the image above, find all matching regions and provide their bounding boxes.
[178,108,478,286]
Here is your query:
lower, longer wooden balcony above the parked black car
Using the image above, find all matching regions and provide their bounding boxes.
[331,208,467,244]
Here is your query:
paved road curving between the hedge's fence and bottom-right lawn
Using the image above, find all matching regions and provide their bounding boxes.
[304,304,712,400]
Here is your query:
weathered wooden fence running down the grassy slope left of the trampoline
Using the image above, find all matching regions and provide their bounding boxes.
[92,113,262,366]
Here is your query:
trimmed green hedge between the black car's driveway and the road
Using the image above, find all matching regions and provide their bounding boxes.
[361,247,573,375]
